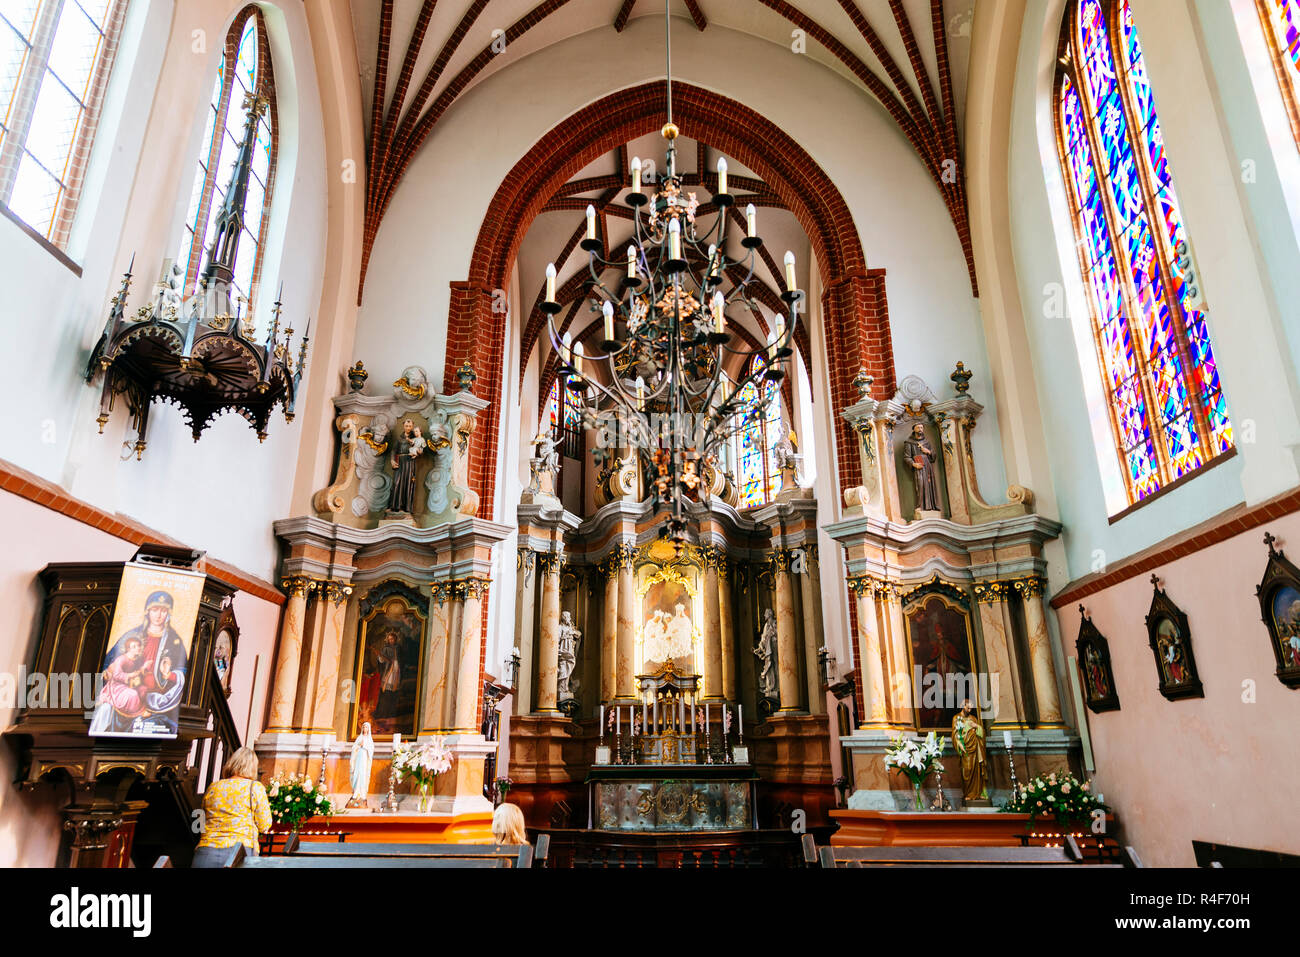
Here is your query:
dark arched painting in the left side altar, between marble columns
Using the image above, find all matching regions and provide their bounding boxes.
[351,581,429,739]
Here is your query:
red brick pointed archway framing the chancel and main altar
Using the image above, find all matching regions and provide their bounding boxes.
[443,81,894,515]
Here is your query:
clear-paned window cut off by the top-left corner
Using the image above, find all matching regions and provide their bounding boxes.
[0,0,127,250]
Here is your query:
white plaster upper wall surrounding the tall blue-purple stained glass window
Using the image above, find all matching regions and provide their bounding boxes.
[1010,0,1296,577]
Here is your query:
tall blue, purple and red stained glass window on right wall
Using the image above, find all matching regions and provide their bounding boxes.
[1056,0,1232,505]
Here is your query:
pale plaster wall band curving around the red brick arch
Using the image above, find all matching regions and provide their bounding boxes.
[356,18,1005,530]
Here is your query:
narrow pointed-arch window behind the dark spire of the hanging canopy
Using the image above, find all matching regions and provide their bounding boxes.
[176,7,278,313]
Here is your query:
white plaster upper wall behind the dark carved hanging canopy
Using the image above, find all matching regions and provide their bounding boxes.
[0,0,326,576]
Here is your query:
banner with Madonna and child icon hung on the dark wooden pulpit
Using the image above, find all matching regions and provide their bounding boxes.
[90,562,207,737]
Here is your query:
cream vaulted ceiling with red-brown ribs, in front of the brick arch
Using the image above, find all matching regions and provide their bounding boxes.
[351,0,975,298]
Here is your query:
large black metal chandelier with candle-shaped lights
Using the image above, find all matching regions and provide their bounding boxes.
[541,1,805,542]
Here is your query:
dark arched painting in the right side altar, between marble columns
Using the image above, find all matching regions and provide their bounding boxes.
[902,580,977,731]
